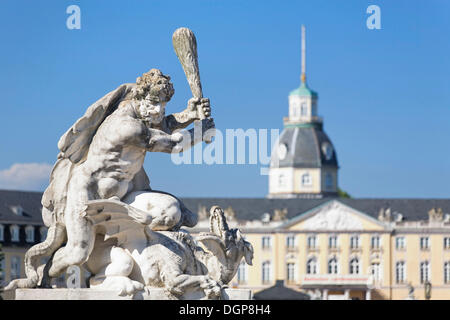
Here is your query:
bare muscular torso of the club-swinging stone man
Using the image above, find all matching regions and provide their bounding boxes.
[75,101,155,199]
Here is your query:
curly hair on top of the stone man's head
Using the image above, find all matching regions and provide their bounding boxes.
[134,69,175,102]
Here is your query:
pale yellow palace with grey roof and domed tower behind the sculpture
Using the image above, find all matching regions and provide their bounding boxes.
[0,28,450,300]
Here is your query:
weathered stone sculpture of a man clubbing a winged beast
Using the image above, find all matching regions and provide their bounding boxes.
[6,28,253,298]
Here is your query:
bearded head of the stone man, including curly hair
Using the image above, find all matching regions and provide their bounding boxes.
[134,69,174,124]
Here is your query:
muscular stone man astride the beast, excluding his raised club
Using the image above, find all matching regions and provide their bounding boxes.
[6,69,214,290]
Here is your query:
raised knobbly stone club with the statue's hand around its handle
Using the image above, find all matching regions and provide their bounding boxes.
[172,28,212,143]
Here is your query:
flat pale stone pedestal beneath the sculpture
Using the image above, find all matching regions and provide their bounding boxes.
[4,288,253,300]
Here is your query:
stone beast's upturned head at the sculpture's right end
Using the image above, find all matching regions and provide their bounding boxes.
[197,206,253,283]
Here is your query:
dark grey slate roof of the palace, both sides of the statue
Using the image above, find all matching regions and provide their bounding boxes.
[0,190,450,224]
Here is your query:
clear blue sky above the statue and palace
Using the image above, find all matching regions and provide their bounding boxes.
[0,0,450,198]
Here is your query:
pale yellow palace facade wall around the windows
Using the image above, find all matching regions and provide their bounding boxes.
[232,230,450,300]
